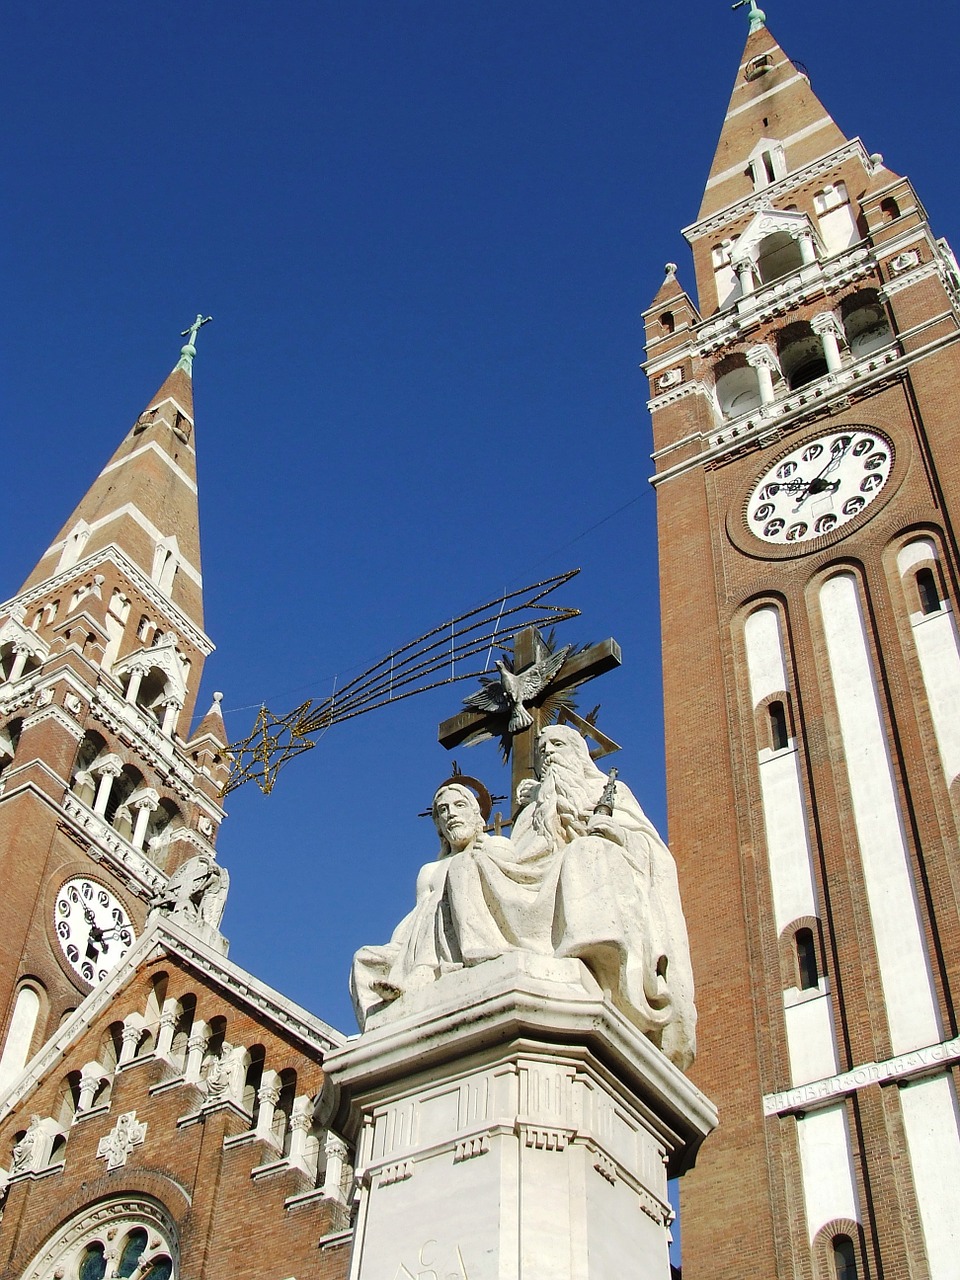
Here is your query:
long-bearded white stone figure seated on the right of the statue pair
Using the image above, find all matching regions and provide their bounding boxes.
[512,724,696,1070]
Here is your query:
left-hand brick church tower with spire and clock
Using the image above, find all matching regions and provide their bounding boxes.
[0,326,225,1093]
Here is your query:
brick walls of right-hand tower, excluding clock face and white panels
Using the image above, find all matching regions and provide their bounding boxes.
[645,27,960,1280]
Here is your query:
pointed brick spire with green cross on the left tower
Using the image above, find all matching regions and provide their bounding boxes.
[22,325,209,628]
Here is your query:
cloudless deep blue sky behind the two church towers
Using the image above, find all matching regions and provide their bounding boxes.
[0,0,960,1198]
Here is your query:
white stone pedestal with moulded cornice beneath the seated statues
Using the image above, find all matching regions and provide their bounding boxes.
[325,952,717,1280]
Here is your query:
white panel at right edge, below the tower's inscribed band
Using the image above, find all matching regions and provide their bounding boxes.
[900,1075,960,1280]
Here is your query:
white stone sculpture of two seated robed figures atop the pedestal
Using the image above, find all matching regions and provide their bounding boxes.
[351,726,696,1069]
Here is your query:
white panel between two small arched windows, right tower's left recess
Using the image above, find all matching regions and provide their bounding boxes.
[759,750,818,936]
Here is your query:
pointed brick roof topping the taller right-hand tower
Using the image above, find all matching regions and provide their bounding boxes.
[696,23,847,221]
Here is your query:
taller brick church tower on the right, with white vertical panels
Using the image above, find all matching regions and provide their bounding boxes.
[645,12,960,1280]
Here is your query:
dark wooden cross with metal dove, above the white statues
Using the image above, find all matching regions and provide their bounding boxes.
[438,627,622,804]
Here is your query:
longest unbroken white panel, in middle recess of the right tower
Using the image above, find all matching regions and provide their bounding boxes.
[820,573,940,1053]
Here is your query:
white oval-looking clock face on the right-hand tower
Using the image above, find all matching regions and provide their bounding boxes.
[746,426,893,547]
